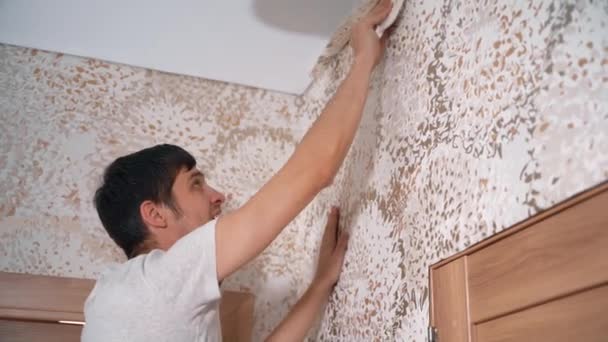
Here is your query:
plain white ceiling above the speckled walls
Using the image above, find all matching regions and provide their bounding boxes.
[0,0,356,94]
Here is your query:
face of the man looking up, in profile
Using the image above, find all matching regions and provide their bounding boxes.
[171,168,226,236]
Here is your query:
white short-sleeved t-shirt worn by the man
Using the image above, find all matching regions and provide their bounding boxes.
[82,220,222,342]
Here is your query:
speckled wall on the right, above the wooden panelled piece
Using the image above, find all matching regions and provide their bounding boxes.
[308,1,608,341]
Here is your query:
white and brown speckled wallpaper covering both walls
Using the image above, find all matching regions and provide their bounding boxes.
[0,0,608,341]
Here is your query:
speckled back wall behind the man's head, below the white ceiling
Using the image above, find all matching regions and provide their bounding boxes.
[0,45,322,336]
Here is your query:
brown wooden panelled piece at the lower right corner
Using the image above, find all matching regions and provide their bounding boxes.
[429,183,608,342]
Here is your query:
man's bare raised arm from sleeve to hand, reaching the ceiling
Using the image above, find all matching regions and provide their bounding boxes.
[216,0,392,280]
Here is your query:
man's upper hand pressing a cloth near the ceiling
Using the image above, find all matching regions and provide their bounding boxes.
[350,0,393,69]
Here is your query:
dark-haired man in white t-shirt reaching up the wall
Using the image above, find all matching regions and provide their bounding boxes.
[82,0,391,342]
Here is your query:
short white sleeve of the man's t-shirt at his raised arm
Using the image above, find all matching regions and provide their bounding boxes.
[144,220,220,310]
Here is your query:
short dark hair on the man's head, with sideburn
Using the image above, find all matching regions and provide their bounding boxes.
[94,144,196,258]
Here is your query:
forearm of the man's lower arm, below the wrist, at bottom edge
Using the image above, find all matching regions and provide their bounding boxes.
[266,283,331,342]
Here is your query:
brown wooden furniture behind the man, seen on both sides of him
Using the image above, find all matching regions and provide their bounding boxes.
[0,272,254,342]
